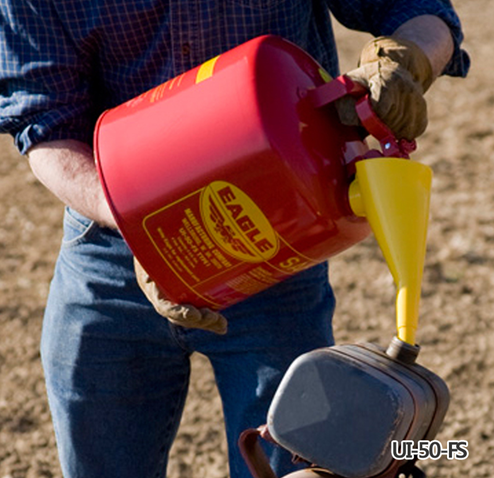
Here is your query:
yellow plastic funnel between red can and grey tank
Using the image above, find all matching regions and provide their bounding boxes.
[349,158,432,345]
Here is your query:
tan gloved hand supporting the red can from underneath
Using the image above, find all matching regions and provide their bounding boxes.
[134,258,227,335]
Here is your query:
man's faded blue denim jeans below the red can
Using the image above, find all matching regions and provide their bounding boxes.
[41,209,334,478]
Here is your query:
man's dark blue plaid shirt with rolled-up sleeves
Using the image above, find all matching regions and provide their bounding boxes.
[0,0,468,153]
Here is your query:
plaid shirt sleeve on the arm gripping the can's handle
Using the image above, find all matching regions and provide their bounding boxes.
[326,0,470,77]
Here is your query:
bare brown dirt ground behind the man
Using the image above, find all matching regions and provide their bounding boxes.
[0,0,494,478]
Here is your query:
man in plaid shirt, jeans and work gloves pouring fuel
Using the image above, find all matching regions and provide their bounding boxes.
[0,0,468,478]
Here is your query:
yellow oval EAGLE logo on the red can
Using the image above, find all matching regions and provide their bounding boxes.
[200,181,279,263]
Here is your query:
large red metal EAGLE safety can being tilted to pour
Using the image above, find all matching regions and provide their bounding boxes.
[94,36,376,309]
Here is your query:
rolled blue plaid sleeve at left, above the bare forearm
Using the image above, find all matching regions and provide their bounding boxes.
[0,0,95,154]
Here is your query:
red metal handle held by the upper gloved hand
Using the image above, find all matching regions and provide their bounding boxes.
[309,75,417,159]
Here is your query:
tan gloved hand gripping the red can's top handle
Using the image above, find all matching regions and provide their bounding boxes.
[336,37,433,141]
